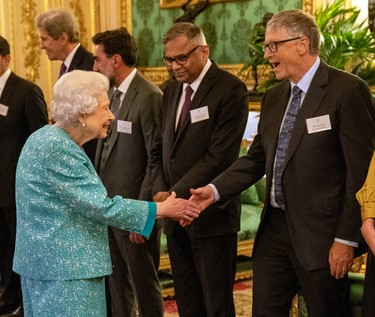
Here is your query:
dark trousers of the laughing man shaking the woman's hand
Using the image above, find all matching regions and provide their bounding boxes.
[253,208,347,317]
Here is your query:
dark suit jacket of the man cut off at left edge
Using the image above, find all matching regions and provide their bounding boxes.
[0,73,48,207]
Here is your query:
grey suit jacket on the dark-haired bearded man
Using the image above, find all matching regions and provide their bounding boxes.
[95,72,163,201]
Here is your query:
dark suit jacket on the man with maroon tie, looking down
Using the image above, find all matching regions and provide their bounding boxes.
[163,63,248,237]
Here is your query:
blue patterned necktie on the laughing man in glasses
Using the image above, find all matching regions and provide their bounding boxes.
[274,86,302,210]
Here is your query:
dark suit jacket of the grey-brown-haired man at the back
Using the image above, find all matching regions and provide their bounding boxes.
[68,45,98,164]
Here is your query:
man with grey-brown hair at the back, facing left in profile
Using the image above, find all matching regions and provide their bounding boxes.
[35,8,97,163]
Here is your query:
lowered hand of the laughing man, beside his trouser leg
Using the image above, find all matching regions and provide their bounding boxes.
[328,241,354,279]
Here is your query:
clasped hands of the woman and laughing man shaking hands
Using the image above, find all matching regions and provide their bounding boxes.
[153,186,215,227]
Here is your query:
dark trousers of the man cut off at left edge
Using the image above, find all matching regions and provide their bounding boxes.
[0,207,22,306]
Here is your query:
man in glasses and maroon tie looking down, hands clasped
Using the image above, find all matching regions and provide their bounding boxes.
[155,22,248,317]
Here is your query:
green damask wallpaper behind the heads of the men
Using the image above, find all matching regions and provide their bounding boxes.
[132,0,301,67]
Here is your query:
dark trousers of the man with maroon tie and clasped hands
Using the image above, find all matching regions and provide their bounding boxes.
[167,225,237,317]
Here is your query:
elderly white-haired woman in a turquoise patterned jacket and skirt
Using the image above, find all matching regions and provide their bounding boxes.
[13,70,199,317]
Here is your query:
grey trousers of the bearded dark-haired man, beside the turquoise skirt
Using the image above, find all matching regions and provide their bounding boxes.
[107,224,164,317]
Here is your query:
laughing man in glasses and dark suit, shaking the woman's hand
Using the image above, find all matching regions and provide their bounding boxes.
[192,10,375,317]
